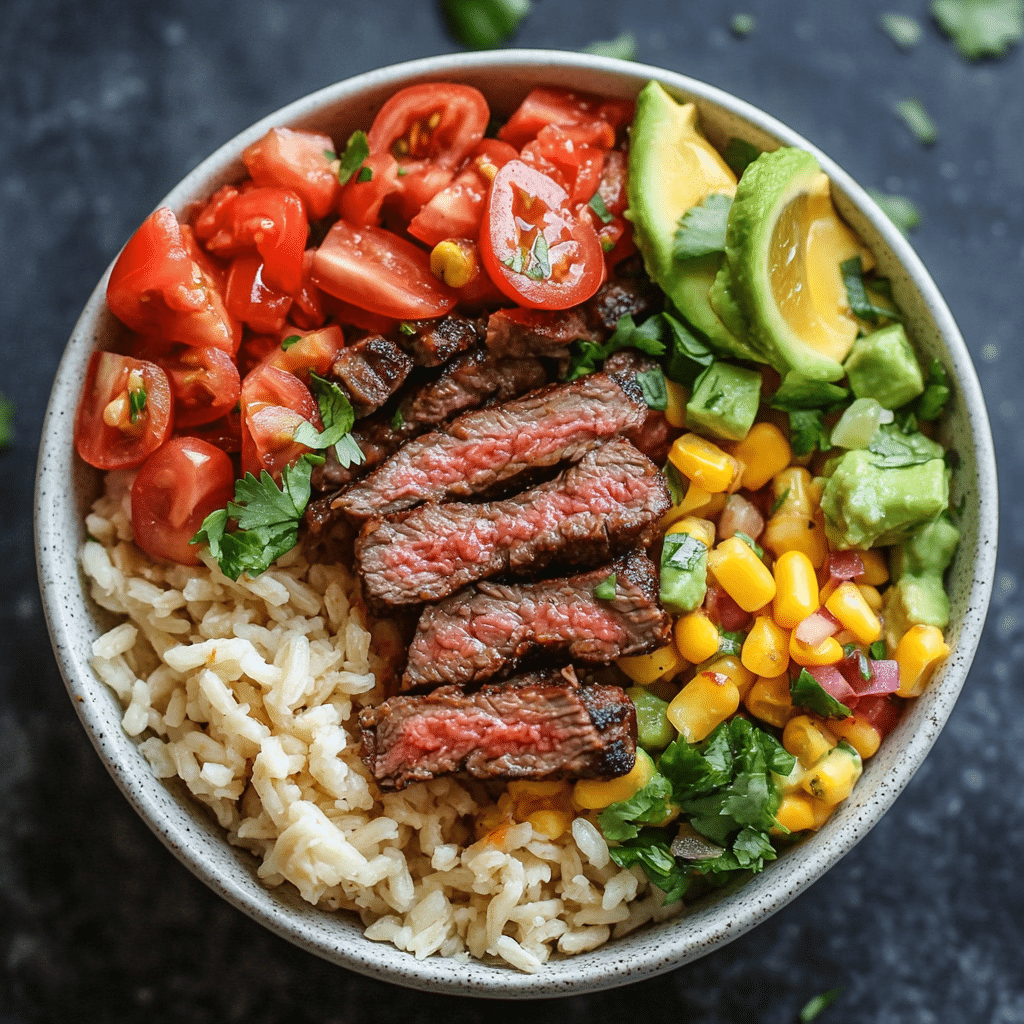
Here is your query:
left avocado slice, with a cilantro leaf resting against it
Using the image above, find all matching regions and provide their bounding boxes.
[626,82,763,361]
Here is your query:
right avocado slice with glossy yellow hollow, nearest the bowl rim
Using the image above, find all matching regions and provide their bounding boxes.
[725,146,860,381]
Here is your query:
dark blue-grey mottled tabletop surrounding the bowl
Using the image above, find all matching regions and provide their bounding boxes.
[0,0,1024,1024]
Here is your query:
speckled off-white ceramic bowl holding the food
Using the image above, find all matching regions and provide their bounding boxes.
[36,50,997,997]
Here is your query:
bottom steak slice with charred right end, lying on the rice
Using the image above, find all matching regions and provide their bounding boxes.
[359,672,637,790]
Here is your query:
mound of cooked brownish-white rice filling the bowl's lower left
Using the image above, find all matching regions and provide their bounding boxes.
[82,473,678,972]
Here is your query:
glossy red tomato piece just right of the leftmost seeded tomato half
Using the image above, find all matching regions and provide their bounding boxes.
[139,345,241,429]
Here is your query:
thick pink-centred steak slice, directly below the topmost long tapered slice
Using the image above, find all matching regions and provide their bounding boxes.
[355,438,672,604]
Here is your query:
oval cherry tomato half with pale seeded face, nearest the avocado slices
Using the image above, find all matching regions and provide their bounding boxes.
[480,160,604,309]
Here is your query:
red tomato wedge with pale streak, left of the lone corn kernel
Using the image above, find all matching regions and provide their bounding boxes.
[312,220,457,319]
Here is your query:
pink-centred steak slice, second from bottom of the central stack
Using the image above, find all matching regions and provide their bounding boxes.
[401,551,671,690]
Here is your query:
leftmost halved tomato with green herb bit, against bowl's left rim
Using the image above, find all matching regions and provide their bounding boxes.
[75,352,172,469]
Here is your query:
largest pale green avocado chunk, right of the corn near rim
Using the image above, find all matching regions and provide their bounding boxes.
[821,450,949,550]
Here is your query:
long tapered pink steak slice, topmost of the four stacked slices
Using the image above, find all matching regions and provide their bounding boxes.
[333,373,647,520]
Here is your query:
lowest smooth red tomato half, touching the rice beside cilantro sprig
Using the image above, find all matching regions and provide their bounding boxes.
[131,437,234,565]
